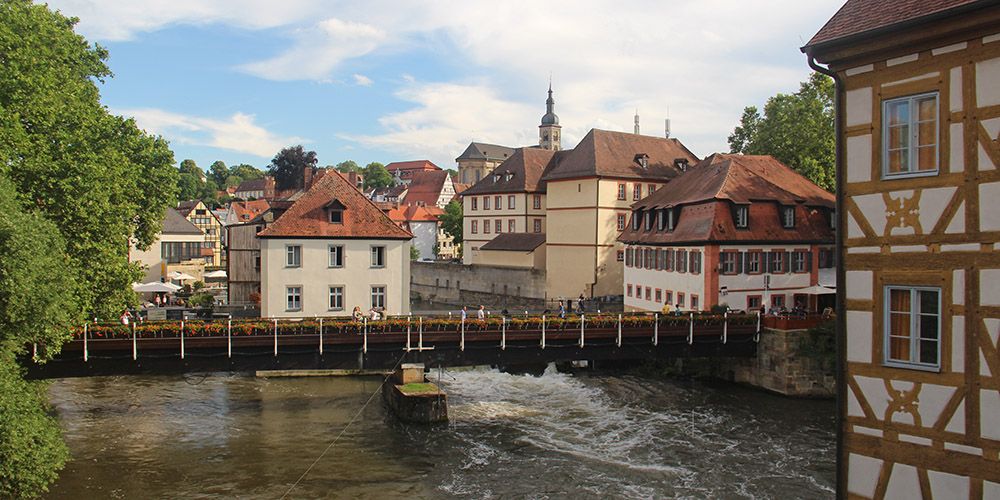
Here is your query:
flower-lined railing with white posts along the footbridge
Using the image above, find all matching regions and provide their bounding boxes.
[72,313,760,340]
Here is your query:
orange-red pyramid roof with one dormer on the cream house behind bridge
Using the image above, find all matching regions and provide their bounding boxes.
[258,171,413,240]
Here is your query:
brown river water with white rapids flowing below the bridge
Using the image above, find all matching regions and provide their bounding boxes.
[49,367,835,499]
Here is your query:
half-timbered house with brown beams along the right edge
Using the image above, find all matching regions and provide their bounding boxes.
[803,0,1000,499]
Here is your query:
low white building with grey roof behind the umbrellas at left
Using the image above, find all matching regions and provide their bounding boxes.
[129,208,205,283]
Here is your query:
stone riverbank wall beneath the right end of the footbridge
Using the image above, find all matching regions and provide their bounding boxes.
[666,328,836,398]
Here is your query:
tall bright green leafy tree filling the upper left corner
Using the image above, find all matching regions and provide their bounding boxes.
[0,0,178,318]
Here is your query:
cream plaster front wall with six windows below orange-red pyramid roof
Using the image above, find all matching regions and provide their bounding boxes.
[261,238,410,318]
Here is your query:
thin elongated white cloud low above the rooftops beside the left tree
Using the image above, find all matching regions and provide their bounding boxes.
[115,108,307,158]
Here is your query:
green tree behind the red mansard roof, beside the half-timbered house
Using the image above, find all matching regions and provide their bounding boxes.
[729,72,836,191]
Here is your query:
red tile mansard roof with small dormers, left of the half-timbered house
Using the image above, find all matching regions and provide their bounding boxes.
[618,154,836,245]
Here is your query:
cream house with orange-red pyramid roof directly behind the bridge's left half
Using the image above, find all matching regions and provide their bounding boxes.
[258,172,413,317]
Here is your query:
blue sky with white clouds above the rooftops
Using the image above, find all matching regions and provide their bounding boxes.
[49,0,844,172]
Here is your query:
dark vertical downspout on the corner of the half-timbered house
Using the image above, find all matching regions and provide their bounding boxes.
[809,55,847,499]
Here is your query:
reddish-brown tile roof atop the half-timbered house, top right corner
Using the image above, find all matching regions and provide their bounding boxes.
[806,0,995,47]
